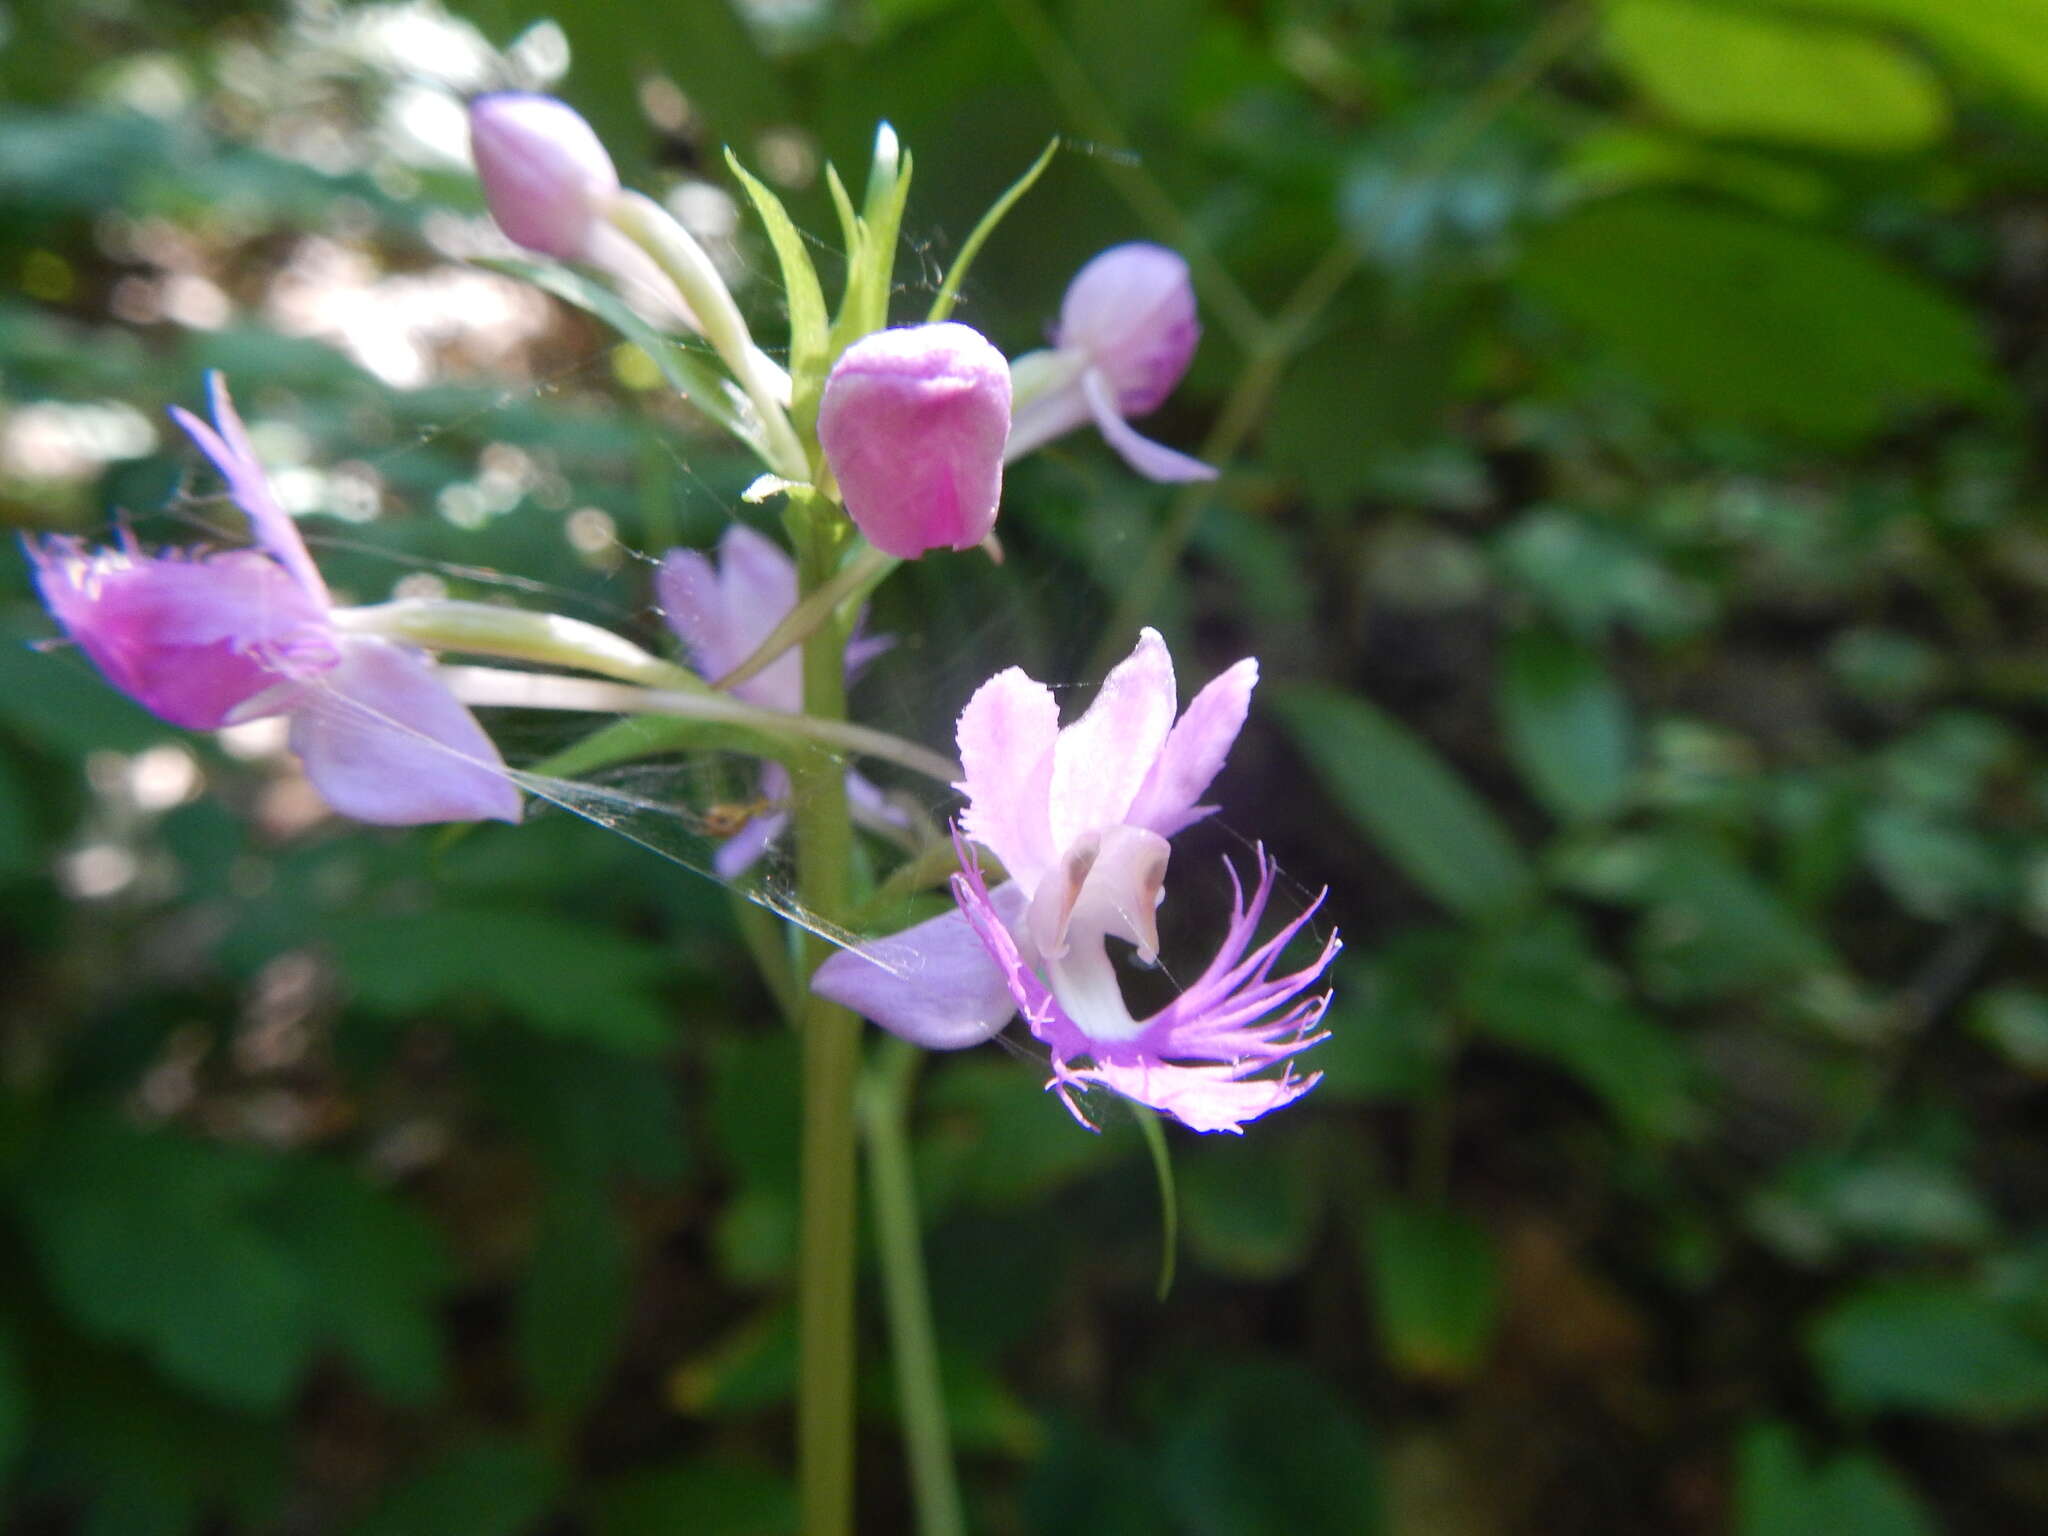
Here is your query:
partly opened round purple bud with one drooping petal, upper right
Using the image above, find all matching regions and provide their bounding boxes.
[1004,242,1217,481]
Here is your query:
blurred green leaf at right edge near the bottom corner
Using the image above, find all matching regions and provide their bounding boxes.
[1810,1280,2048,1423]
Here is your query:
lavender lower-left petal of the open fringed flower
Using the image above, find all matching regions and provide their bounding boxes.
[811,883,1024,1051]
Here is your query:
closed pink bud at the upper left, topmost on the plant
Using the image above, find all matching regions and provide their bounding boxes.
[469,90,618,262]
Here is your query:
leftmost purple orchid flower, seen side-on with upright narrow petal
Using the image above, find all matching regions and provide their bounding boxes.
[29,373,520,825]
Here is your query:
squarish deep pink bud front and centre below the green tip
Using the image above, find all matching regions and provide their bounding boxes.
[817,322,1010,559]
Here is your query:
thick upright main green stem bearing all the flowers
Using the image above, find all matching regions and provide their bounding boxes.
[788,502,860,1536]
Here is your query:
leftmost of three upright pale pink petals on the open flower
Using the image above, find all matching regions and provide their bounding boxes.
[954,668,1059,887]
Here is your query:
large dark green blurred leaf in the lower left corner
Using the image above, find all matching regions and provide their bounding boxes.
[23,1116,313,1409]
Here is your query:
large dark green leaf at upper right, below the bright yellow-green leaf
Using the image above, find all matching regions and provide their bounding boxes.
[1522,195,2003,440]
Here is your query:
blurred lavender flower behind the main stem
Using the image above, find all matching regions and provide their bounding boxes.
[653,522,905,881]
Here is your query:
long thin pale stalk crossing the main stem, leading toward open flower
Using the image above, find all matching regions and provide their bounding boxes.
[440,667,961,786]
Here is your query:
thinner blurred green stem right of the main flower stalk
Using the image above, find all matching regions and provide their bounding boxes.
[860,1036,967,1536]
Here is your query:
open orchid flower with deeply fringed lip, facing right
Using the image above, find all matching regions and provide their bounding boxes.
[811,629,1339,1130]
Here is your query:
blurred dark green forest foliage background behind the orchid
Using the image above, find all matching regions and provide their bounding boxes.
[0,0,2048,1536]
